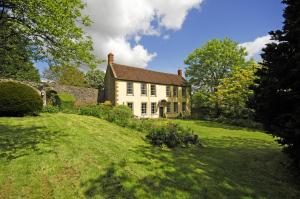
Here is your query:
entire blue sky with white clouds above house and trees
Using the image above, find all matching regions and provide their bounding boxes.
[37,0,283,72]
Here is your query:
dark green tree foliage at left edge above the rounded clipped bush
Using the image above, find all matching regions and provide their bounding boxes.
[0,15,40,82]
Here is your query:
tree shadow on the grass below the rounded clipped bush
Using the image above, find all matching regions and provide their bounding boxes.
[0,124,61,161]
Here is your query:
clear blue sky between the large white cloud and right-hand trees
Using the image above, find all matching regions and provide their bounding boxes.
[141,0,284,72]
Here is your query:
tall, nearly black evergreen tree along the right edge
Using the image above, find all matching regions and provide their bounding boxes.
[253,0,300,167]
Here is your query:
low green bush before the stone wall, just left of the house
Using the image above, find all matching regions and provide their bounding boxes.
[79,104,112,119]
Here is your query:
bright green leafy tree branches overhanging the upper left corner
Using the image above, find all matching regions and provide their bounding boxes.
[0,0,97,67]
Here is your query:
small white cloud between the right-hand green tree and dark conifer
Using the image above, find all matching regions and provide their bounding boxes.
[240,35,271,59]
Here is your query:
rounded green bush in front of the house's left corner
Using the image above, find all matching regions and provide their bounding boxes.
[107,105,133,127]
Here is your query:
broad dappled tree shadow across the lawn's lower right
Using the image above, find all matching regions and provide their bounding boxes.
[82,138,300,199]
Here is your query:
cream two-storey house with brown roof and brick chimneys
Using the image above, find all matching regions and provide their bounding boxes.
[104,53,191,118]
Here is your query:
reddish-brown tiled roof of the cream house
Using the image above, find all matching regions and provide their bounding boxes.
[110,63,187,86]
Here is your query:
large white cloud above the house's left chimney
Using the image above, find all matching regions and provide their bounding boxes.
[85,0,203,67]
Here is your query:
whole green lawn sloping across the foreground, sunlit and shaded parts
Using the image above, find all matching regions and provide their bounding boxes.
[0,113,300,199]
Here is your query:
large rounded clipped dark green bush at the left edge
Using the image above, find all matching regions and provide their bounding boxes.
[0,82,43,116]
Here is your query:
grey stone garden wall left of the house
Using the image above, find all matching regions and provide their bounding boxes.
[46,84,100,106]
